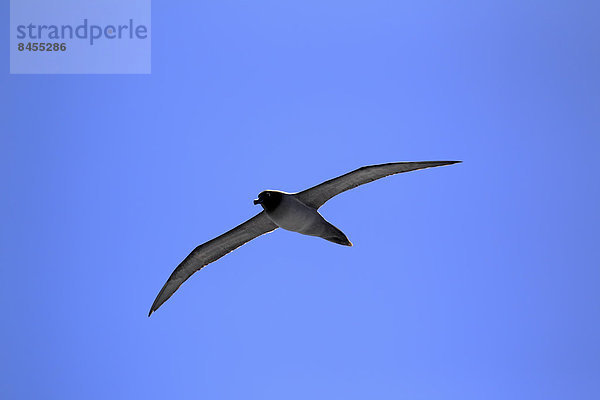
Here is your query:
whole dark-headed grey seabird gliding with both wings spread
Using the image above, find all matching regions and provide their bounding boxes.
[148,161,460,316]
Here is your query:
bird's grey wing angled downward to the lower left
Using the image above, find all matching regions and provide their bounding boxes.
[148,211,277,316]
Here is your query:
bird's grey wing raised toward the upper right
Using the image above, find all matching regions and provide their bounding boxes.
[296,161,460,209]
